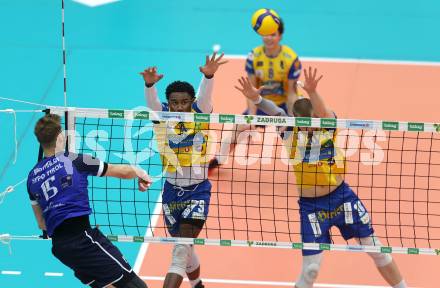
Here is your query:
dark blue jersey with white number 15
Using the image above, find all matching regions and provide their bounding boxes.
[27,153,107,236]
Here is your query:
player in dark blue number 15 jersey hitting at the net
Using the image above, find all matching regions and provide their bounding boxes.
[27,114,151,288]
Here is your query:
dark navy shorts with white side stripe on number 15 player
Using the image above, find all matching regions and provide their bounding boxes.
[52,228,135,288]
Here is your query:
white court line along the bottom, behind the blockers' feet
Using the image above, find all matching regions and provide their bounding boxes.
[140,276,415,288]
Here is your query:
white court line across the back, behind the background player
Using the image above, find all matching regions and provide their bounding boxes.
[224,54,440,67]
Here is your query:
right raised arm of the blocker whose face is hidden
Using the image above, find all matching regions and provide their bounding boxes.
[303,67,335,118]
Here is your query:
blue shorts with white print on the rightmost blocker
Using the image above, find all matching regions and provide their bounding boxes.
[298,182,374,255]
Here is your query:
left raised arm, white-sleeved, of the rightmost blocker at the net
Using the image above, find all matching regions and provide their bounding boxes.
[235,77,287,116]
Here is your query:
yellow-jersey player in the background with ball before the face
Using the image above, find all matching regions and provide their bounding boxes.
[210,21,301,169]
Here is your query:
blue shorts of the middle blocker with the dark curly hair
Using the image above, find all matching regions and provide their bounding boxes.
[162,179,212,237]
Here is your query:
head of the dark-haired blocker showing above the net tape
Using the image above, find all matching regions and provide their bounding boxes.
[165,81,196,112]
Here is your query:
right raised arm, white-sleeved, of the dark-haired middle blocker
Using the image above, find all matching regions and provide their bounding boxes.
[196,52,228,113]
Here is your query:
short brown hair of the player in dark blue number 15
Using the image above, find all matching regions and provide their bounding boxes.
[34,114,61,148]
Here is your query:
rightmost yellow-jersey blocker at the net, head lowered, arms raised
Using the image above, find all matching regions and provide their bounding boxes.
[236,68,407,288]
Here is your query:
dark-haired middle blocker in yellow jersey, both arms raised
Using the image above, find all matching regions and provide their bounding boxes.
[141,53,226,288]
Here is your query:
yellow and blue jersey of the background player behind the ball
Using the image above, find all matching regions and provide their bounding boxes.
[245,45,301,106]
